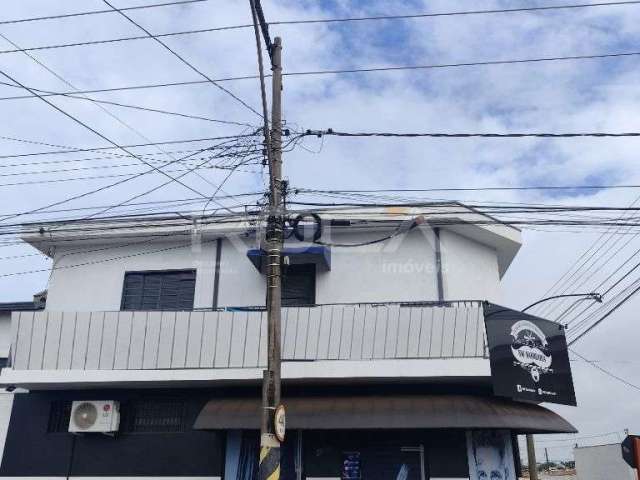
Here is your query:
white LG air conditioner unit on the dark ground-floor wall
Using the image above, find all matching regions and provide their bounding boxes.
[69,400,120,433]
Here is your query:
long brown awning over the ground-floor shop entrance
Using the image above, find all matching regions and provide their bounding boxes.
[194,395,577,433]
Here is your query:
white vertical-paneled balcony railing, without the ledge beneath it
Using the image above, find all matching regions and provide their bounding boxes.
[11,302,486,370]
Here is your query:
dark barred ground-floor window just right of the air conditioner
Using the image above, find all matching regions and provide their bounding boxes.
[121,400,186,433]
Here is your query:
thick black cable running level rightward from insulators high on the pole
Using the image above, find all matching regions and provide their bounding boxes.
[301,128,640,138]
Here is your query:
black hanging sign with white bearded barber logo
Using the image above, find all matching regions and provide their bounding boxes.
[484,303,576,405]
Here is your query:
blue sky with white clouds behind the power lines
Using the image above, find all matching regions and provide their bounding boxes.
[0,0,640,462]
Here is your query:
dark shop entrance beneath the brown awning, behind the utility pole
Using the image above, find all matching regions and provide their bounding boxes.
[224,430,469,480]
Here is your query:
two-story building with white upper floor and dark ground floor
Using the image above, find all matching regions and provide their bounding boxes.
[0,203,575,480]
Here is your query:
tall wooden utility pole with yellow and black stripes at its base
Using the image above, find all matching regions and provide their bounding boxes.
[259,37,284,480]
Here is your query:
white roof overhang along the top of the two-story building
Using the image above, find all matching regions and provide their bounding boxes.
[21,202,521,276]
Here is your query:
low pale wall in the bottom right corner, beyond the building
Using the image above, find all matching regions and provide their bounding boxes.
[573,443,636,480]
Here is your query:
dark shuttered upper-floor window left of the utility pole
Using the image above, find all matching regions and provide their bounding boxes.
[121,270,196,311]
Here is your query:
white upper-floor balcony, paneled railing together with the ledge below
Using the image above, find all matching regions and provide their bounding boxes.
[0,301,490,389]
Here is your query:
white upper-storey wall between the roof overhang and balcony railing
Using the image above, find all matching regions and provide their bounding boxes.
[43,228,499,312]
